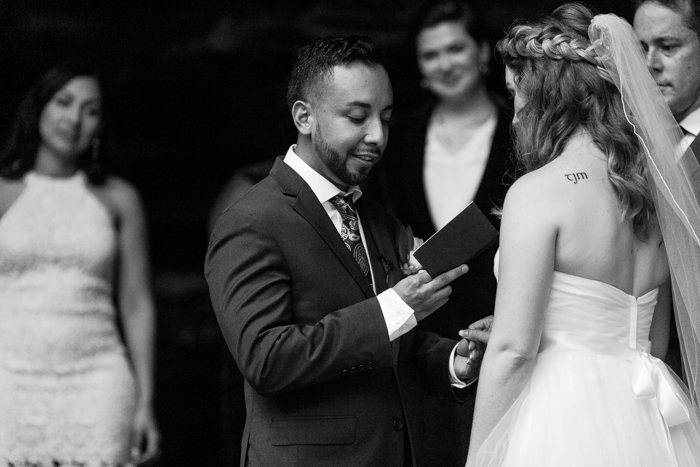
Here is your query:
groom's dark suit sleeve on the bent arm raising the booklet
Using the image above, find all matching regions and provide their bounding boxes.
[205,210,392,395]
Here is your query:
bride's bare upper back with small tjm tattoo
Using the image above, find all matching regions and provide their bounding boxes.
[526,135,669,296]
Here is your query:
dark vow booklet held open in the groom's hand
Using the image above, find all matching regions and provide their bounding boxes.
[413,202,498,277]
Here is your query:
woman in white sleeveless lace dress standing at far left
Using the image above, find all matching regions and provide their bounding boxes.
[0,60,159,467]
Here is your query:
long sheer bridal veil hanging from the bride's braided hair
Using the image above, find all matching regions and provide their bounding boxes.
[588,14,700,405]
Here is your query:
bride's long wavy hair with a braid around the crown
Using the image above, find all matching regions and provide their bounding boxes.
[496,3,655,240]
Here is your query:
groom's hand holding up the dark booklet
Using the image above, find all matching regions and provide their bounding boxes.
[393,264,469,321]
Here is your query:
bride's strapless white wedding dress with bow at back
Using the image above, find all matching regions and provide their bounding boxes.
[477,252,700,467]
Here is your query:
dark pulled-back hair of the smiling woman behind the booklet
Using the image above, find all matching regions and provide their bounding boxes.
[411,0,490,44]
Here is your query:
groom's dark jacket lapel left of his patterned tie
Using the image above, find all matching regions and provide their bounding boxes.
[270,157,374,297]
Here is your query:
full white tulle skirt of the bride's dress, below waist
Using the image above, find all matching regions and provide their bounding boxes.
[476,351,700,467]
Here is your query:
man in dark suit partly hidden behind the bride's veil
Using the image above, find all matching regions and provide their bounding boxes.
[633,0,700,375]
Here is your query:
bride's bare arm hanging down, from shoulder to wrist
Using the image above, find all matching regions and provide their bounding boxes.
[467,176,558,465]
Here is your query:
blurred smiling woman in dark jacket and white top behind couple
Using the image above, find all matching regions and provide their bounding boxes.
[371,1,512,465]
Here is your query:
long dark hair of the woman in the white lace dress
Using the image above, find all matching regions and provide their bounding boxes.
[0,58,109,185]
